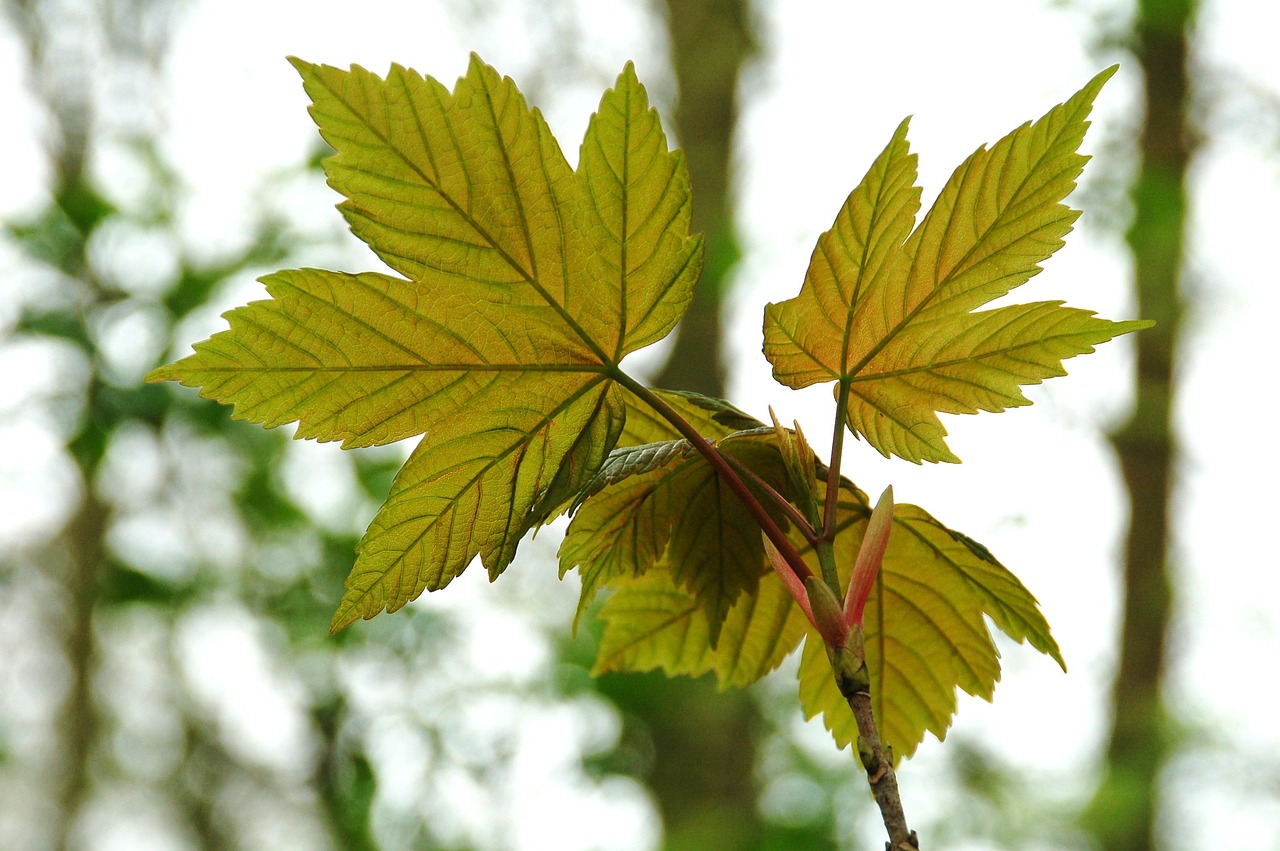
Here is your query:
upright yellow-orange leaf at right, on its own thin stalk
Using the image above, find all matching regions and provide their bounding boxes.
[764,68,1149,463]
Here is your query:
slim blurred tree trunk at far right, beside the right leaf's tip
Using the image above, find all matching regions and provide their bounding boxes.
[1092,0,1196,851]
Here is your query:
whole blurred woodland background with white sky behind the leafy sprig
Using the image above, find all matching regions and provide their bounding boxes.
[0,0,1280,851]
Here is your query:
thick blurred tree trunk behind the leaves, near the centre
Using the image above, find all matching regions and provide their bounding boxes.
[602,0,763,851]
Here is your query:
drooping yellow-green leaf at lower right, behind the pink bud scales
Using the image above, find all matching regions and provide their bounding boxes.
[800,494,1065,758]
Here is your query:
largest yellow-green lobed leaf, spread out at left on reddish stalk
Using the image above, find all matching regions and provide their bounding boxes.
[148,58,701,630]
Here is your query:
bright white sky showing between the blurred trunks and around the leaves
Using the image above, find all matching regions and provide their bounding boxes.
[0,0,1280,848]
